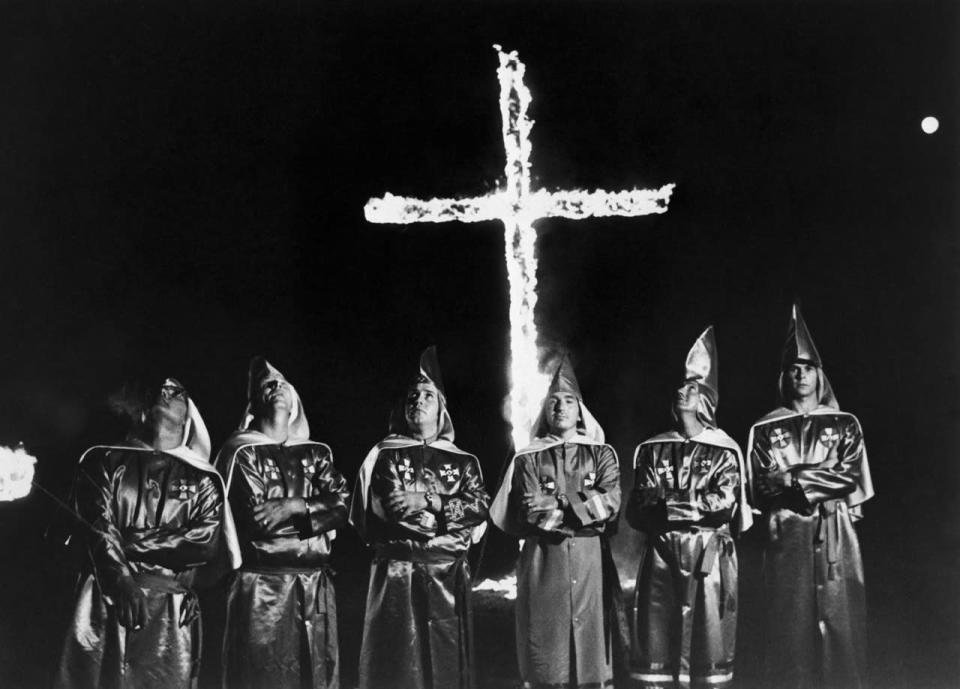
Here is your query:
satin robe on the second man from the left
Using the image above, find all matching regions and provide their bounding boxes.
[223,443,350,689]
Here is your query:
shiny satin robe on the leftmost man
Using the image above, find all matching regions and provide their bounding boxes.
[55,448,224,689]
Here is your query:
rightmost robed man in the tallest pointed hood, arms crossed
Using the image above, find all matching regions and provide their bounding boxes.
[747,306,873,689]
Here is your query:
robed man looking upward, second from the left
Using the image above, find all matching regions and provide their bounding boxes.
[217,357,349,689]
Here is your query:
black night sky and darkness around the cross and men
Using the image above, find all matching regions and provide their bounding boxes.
[0,0,960,688]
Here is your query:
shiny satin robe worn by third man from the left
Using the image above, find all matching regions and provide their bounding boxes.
[360,444,490,689]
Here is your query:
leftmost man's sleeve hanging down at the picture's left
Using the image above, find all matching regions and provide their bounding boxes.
[76,455,131,595]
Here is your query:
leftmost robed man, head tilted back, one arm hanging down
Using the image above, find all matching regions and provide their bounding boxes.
[55,378,240,689]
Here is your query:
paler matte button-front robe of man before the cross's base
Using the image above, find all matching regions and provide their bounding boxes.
[510,440,620,689]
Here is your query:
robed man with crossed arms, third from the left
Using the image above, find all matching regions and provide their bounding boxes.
[350,347,490,689]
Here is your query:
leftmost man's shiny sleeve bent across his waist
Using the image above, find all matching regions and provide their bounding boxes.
[118,476,223,571]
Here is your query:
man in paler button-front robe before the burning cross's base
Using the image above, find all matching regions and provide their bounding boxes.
[490,356,620,689]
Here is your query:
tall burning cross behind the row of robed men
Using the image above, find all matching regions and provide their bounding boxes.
[364,45,674,449]
